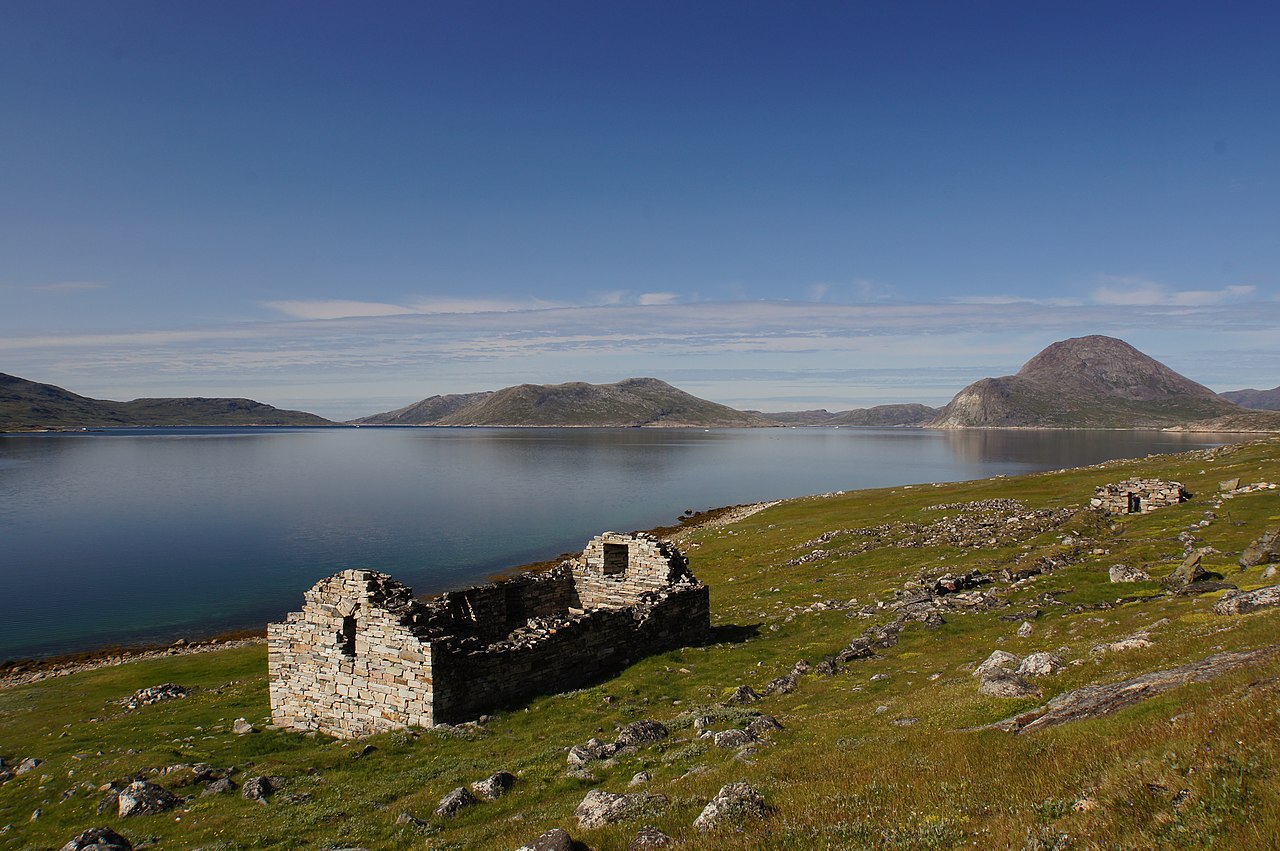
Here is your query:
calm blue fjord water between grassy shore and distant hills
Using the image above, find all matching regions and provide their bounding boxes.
[0,429,1231,659]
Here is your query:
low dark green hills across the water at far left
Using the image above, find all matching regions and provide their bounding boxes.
[0,372,333,431]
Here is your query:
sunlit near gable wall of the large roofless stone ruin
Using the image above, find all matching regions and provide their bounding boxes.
[266,571,434,737]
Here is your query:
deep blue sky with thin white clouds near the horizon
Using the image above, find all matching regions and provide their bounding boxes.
[0,0,1280,417]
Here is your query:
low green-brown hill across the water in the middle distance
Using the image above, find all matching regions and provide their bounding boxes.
[355,379,773,427]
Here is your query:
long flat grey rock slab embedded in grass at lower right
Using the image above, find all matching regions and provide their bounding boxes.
[979,648,1277,733]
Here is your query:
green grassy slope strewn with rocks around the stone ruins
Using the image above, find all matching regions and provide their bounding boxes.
[0,441,1280,848]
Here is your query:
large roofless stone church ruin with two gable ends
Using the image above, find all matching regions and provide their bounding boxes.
[266,532,710,738]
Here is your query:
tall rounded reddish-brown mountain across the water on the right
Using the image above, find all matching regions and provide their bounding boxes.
[928,337,1245,429]
